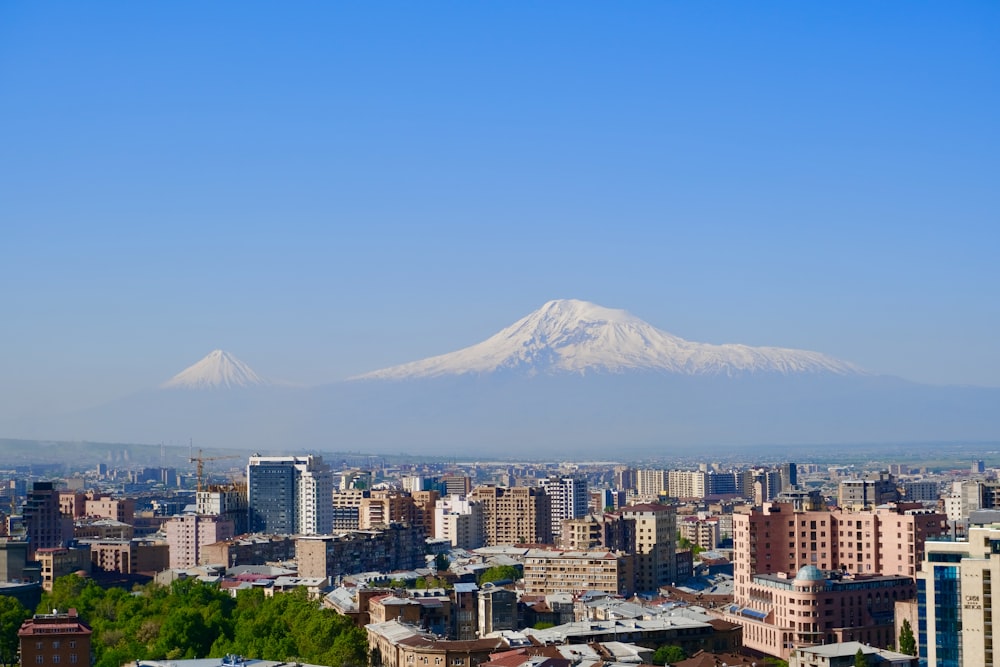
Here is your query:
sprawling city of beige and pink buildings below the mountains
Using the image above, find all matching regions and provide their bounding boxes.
[0,442,1000,667]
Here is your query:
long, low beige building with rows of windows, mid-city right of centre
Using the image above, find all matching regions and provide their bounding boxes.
[523,549,635,596]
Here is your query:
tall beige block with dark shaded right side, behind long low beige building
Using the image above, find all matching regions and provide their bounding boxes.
[613,504,677,591]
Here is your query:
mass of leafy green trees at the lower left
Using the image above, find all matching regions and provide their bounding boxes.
[40,575,368,667]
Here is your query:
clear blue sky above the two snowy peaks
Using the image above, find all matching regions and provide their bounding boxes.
[0,2,1000,413]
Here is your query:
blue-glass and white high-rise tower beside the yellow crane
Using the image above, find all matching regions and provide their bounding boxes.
[247,454,333,535]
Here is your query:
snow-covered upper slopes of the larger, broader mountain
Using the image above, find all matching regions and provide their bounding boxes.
[354,299,863,379]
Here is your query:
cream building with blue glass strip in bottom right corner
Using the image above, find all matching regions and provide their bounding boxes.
[913,524,1000,667]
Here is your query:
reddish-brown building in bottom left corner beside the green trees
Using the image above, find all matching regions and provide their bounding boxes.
[17,609,91,667]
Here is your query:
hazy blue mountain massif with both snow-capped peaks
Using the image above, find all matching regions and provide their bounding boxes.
[0,300,1000,459]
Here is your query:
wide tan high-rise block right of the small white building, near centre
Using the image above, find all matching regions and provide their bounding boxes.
[469,486,552,546]
